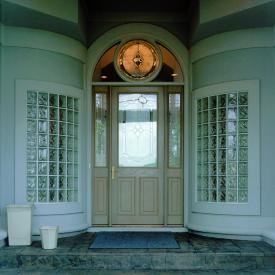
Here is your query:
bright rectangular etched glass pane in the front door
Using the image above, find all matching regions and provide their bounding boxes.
[118,94,157,167]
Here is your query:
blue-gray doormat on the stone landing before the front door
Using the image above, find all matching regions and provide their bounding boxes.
[90,232,179,249]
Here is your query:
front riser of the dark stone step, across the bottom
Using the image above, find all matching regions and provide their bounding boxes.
[0,251,275,273]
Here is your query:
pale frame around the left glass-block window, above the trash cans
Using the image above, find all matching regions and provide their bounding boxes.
[15,79,84,215]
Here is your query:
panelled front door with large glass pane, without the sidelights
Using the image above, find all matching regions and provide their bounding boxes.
[111,87,164,225]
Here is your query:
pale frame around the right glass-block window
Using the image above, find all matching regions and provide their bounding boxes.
[191,80,261,215]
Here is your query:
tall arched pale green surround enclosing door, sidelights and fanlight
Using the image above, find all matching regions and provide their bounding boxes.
[87,23,192,229]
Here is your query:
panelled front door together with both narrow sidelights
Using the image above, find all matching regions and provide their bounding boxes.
[92,86,183,226]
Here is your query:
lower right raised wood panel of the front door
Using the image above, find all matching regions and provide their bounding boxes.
[139,177,159,216]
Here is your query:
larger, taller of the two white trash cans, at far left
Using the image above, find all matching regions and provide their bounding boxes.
[7,204,33,245]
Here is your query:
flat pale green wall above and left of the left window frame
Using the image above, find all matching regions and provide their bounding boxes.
[0,46,83,209]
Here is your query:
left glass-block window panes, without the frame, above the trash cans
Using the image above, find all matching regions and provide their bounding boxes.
[27,91,79,203]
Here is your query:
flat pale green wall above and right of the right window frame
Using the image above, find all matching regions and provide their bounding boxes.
[192,47,275,217]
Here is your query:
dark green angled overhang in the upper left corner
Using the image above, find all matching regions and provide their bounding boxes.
[0,0,86,43]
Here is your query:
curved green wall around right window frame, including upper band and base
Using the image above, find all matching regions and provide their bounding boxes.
[190,28,275,239]
